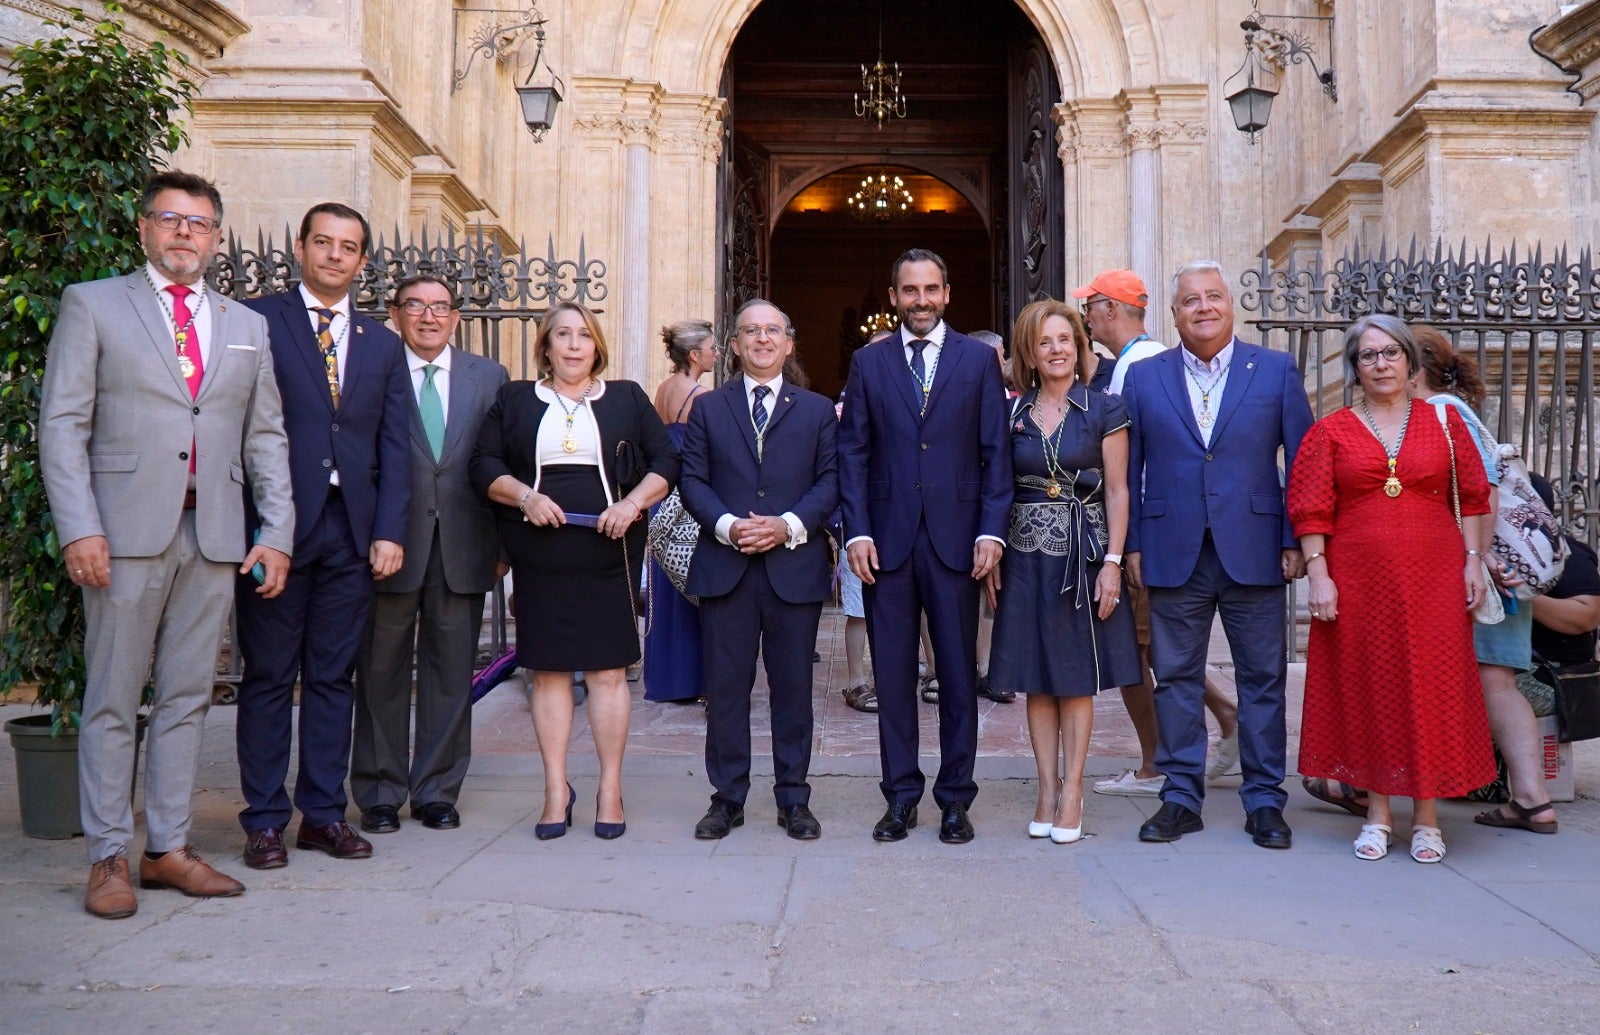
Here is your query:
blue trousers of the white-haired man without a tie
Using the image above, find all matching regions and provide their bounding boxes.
[1150,534,1288,813]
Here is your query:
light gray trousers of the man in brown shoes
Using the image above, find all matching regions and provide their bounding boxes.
[78,510,235,862]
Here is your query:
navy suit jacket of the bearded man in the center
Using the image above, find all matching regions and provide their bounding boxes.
[838,328,1011,571]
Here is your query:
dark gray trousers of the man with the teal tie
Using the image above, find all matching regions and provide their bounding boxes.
[350,531,483,809]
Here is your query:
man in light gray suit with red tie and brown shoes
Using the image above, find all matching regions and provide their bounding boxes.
[38,171,294,918]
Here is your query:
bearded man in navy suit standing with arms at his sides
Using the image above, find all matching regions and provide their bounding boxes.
[838,248,1011,845]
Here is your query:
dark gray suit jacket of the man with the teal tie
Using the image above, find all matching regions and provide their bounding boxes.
[376,349,509,593]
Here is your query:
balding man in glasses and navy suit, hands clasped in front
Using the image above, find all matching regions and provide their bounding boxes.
[678,299,838,841]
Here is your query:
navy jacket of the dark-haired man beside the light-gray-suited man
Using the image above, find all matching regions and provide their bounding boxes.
[245,290,414,555]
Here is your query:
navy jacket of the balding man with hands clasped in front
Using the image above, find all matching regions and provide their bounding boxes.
[678,376,838,603]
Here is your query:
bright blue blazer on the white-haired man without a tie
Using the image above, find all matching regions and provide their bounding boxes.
[1122,338,1312,587]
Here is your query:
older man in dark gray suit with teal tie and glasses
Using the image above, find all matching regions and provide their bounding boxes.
[350,274,507,833]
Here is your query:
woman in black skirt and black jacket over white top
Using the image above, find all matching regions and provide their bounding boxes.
[472,302,678,840]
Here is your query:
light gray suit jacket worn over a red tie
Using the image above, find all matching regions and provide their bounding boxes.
[38,274,294,563]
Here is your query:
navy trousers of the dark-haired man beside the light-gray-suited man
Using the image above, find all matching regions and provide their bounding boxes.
[234,494,373,832]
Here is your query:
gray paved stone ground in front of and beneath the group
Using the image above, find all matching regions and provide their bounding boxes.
[0,619,1600,1033]
